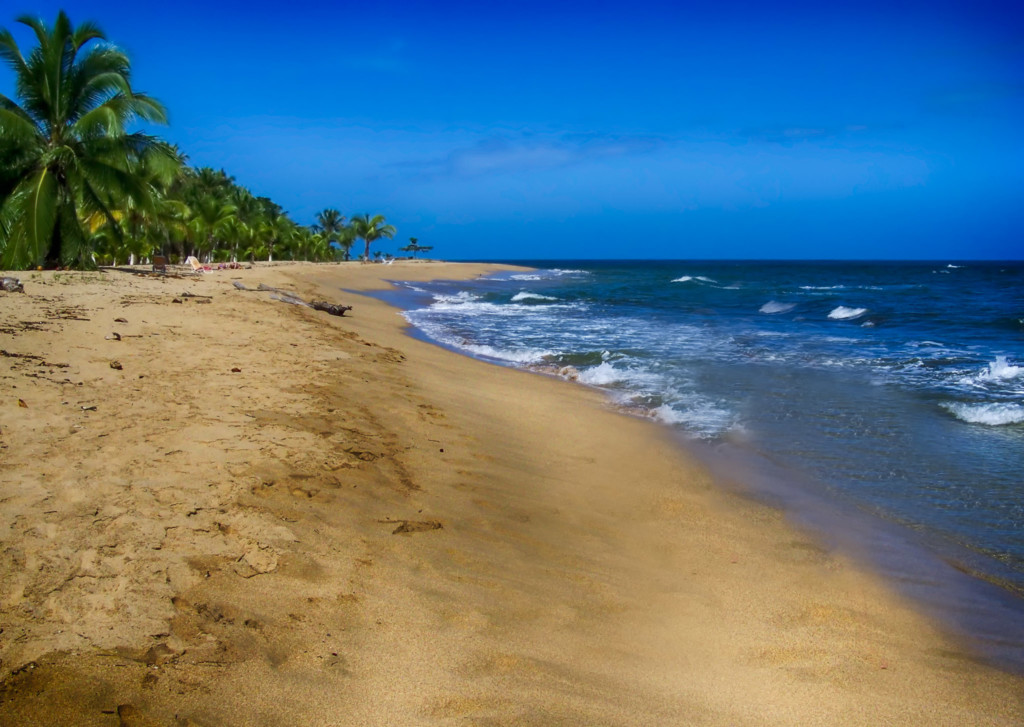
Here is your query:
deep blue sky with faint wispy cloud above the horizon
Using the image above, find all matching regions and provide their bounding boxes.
[0,0,1024,259]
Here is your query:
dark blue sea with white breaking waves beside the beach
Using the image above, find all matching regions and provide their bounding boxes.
[393,261,1024,667]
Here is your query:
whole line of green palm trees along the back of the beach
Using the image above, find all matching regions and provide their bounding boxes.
[0,11,415,269]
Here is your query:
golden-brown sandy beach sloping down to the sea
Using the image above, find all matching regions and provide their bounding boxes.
[0,263,1024,726]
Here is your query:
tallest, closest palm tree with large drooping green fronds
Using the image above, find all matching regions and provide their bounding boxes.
[0,11,166,268]
